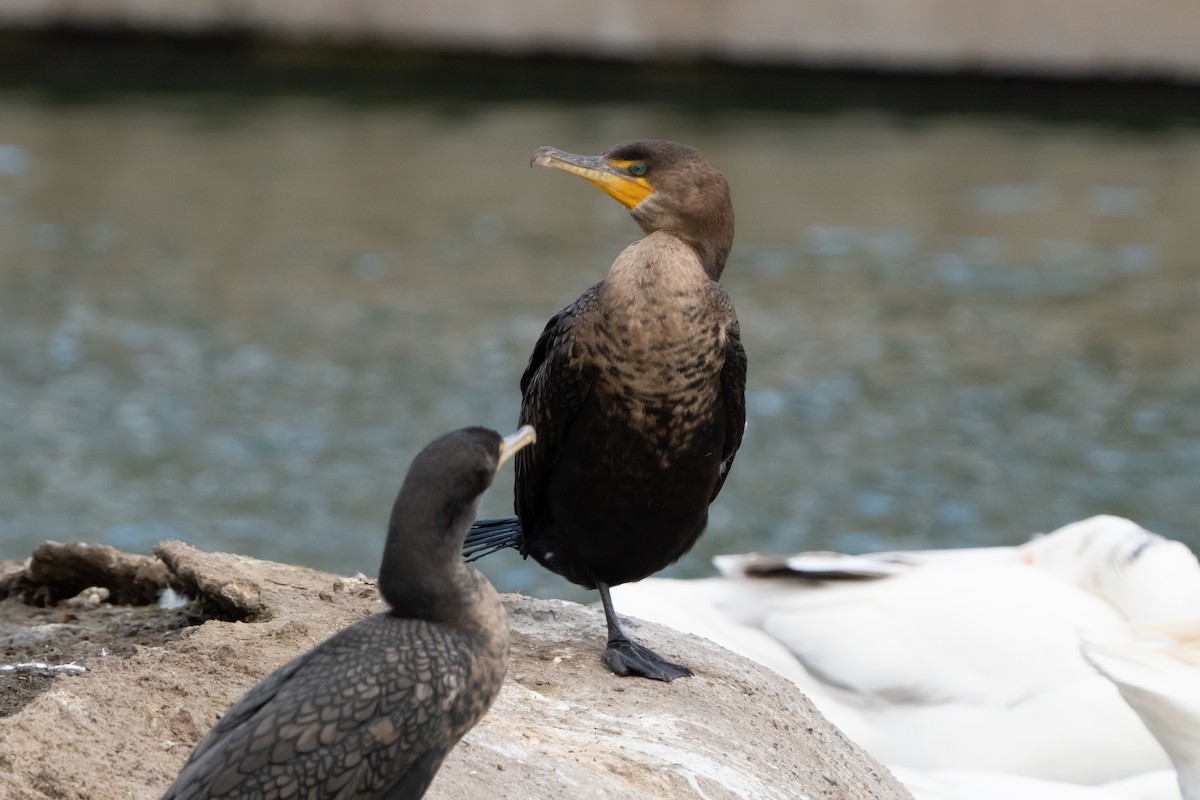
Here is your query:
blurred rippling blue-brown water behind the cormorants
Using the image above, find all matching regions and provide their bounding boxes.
[0,91,1200,597]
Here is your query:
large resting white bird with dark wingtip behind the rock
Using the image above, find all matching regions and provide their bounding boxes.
[616,516,1200,796]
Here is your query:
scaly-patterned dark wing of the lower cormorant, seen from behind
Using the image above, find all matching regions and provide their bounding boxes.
[163,614,469,800]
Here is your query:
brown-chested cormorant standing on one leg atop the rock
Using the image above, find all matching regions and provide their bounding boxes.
[464,140,746,680]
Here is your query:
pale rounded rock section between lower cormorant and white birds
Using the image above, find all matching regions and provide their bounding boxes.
[428,595,908,800]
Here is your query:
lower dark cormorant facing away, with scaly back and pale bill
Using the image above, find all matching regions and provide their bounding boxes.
[163,426,534,800]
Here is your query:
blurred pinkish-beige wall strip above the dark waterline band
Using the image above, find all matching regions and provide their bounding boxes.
[0,0,1200,79]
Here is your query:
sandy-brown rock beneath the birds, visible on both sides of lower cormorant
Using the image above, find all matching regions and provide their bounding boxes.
[0,542,910,800]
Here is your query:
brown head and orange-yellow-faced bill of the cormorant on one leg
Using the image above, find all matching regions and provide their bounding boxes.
[530,139,733,281]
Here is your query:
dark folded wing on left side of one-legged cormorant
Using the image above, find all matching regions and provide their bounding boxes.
[516,283,601,536]
